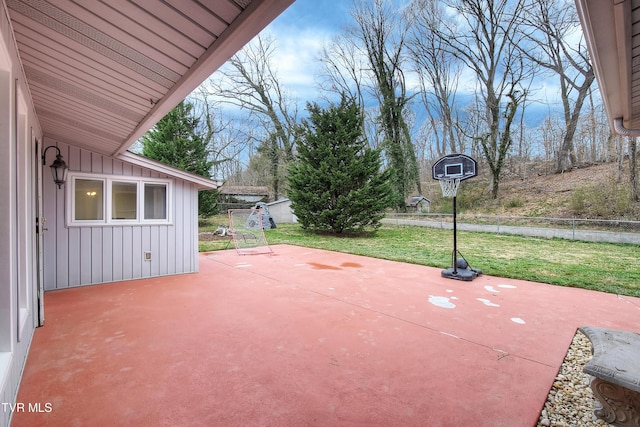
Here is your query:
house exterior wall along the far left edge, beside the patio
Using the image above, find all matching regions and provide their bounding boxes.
[0,1,41,426]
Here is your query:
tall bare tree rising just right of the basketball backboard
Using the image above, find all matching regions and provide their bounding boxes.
[432,0,529,198]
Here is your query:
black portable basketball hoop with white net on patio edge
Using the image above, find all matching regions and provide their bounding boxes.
[431,154,482,281]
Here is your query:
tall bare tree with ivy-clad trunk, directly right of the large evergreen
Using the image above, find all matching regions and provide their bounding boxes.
[321,0,420,209]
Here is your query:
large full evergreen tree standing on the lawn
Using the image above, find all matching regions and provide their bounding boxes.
[288,95,393,233]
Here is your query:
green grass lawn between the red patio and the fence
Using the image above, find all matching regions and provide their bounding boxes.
[200,222,640,297]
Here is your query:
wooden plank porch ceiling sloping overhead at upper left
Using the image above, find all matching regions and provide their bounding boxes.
[6,0,293,155]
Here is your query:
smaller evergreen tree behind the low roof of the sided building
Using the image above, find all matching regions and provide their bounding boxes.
[141,101,218,216]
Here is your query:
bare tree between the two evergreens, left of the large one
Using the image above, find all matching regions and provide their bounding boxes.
[204,35,297,198]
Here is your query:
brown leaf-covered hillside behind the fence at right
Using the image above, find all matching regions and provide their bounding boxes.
[424,162,640,220]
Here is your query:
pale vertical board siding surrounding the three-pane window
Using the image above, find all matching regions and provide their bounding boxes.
[43,140,198,290]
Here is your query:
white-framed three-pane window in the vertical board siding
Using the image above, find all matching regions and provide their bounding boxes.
[67,173,171,226]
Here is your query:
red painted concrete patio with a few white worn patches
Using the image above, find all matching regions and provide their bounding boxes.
[12,245,640,427]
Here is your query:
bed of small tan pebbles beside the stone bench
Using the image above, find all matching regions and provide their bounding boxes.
[536,331,610,427]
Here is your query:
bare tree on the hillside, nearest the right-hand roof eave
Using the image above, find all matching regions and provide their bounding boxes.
[518,0,595,173]
